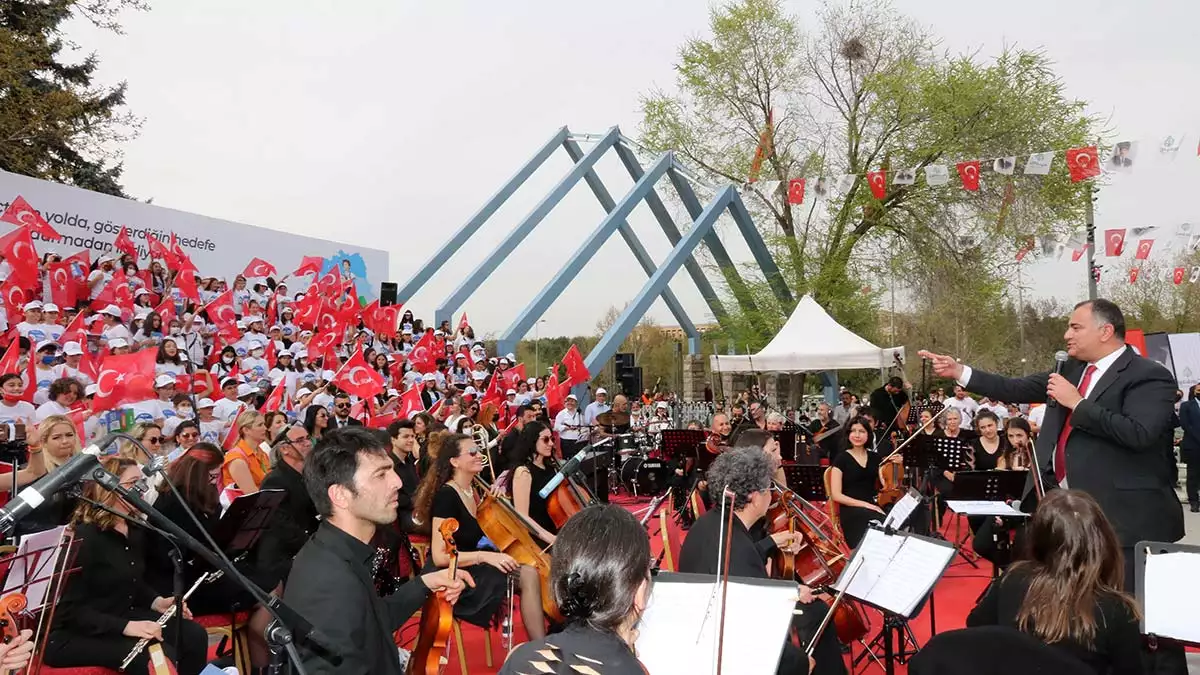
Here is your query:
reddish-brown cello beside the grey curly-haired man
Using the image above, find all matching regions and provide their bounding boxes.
[767,484,871,645]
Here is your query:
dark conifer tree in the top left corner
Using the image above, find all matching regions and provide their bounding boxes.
[0,0,145,197]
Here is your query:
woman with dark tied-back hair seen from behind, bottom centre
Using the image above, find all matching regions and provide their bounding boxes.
[500,504,650,675]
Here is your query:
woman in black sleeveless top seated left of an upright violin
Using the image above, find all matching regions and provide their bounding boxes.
[829,417,901,548]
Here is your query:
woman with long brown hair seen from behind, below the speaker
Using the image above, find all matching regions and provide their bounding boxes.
[967,490,1142,675]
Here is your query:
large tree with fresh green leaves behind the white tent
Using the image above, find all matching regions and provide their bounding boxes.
[641,0,1093,347]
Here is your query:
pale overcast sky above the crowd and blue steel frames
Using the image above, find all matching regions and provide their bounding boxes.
[68,0,1200,336]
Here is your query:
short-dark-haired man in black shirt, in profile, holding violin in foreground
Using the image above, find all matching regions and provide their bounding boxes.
[283,428,474,675]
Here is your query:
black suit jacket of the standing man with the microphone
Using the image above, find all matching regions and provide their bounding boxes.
[967,348,1183,548]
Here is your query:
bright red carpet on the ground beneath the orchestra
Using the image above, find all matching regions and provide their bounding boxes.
[403,497,991,675]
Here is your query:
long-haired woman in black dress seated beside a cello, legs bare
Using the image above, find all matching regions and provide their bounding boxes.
[415,434,546,639]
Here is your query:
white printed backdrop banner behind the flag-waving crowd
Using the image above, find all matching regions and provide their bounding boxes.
[0,171,388,301]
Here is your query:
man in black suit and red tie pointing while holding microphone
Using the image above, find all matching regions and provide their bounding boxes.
[920,299,1183,592]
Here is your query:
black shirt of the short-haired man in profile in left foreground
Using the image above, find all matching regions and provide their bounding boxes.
[283,521,428,675]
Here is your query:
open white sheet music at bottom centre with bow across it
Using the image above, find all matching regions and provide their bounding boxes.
[637,574,797,675]
